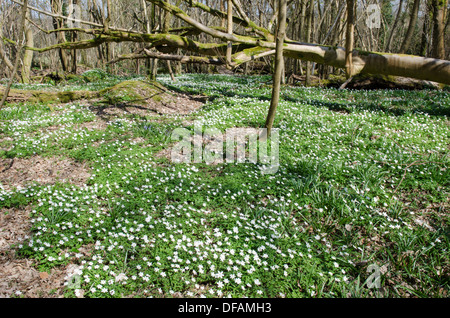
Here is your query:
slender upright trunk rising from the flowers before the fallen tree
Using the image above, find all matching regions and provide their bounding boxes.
[265,0,286,136]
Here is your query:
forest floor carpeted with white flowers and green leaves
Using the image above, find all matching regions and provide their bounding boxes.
[0,74,450,298]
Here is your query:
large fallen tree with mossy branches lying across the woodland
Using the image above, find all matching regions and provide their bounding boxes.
[8,0,450,84]
